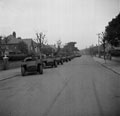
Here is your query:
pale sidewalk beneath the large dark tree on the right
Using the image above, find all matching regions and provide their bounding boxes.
[93,57,120,75]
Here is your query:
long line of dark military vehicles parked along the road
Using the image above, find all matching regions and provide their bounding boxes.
[21,54,81,76]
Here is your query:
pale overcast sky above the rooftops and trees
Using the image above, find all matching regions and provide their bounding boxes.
[0,0,120,49]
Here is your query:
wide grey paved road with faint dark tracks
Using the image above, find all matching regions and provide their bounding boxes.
[0,56,120,116]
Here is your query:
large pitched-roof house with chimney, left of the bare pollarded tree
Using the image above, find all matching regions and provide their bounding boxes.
[1,32,38,55]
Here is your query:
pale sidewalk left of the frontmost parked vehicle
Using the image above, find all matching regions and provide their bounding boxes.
[0,68,20,81]
